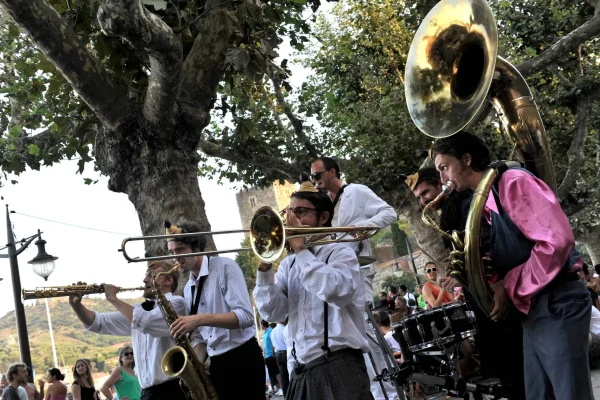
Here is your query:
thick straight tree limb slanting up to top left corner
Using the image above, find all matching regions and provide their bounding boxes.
[0,0,129,127]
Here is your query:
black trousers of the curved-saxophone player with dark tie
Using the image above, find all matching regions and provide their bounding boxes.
[210,338,267,400]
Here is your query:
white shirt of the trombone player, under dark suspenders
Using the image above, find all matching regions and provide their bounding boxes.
[254,243,367,363]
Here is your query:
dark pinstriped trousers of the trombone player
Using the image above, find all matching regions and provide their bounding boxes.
[285,349,373,400]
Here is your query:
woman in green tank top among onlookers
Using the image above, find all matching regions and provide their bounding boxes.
[100,346,142,400]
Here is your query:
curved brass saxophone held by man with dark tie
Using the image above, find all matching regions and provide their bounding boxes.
[152,264,218,400]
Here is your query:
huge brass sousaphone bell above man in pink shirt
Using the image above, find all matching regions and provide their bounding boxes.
[405,0,498,138]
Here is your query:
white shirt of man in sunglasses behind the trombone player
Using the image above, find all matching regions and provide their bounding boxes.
[332,183,397,276]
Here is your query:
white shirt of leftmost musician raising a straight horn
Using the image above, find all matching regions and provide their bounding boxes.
[86,293,188,389]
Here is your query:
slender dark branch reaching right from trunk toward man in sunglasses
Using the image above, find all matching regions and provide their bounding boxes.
[199,140,303,182]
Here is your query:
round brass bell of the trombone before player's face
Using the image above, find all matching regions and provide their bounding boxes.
[250,206,286,263]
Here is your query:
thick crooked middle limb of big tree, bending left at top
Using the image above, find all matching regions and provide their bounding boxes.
[97,0,183,125]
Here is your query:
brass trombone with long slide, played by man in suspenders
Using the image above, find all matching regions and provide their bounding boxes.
[119,206,379,263]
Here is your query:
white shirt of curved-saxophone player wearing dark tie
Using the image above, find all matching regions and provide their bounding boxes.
[183,256,256,357]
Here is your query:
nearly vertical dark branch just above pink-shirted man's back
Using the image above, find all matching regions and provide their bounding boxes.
[558,98,590,200]
